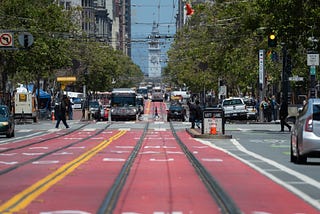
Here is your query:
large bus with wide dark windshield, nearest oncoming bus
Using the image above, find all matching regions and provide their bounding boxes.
[110,88,139,121]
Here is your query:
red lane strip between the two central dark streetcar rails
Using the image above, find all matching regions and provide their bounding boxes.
[114,130,219,214]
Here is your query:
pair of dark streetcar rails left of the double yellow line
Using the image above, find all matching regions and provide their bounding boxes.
[0,124,110,175]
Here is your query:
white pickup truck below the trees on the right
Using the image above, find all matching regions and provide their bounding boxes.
[222,97,248,119]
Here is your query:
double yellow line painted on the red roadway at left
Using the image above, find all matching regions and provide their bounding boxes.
[0,131,126,213]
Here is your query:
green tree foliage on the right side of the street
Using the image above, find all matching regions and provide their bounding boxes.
[165,0,320,96]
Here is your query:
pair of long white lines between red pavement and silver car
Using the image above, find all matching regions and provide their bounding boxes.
[195,139,320,209]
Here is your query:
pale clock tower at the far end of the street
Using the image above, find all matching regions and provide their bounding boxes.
[148,22,161,77]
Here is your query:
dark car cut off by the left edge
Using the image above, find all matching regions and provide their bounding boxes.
[0,105,14,137]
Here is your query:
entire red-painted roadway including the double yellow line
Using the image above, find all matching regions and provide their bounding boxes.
[0,99,319,214]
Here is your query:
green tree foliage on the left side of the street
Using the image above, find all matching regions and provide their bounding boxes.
[0,0,143,91]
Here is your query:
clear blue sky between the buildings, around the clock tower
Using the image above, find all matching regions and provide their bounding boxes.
[131,0,179,74]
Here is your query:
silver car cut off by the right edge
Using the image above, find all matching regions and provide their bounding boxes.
[290,99,320,164]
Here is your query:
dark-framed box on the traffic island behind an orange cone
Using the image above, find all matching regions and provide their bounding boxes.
[202,108,224,135]
